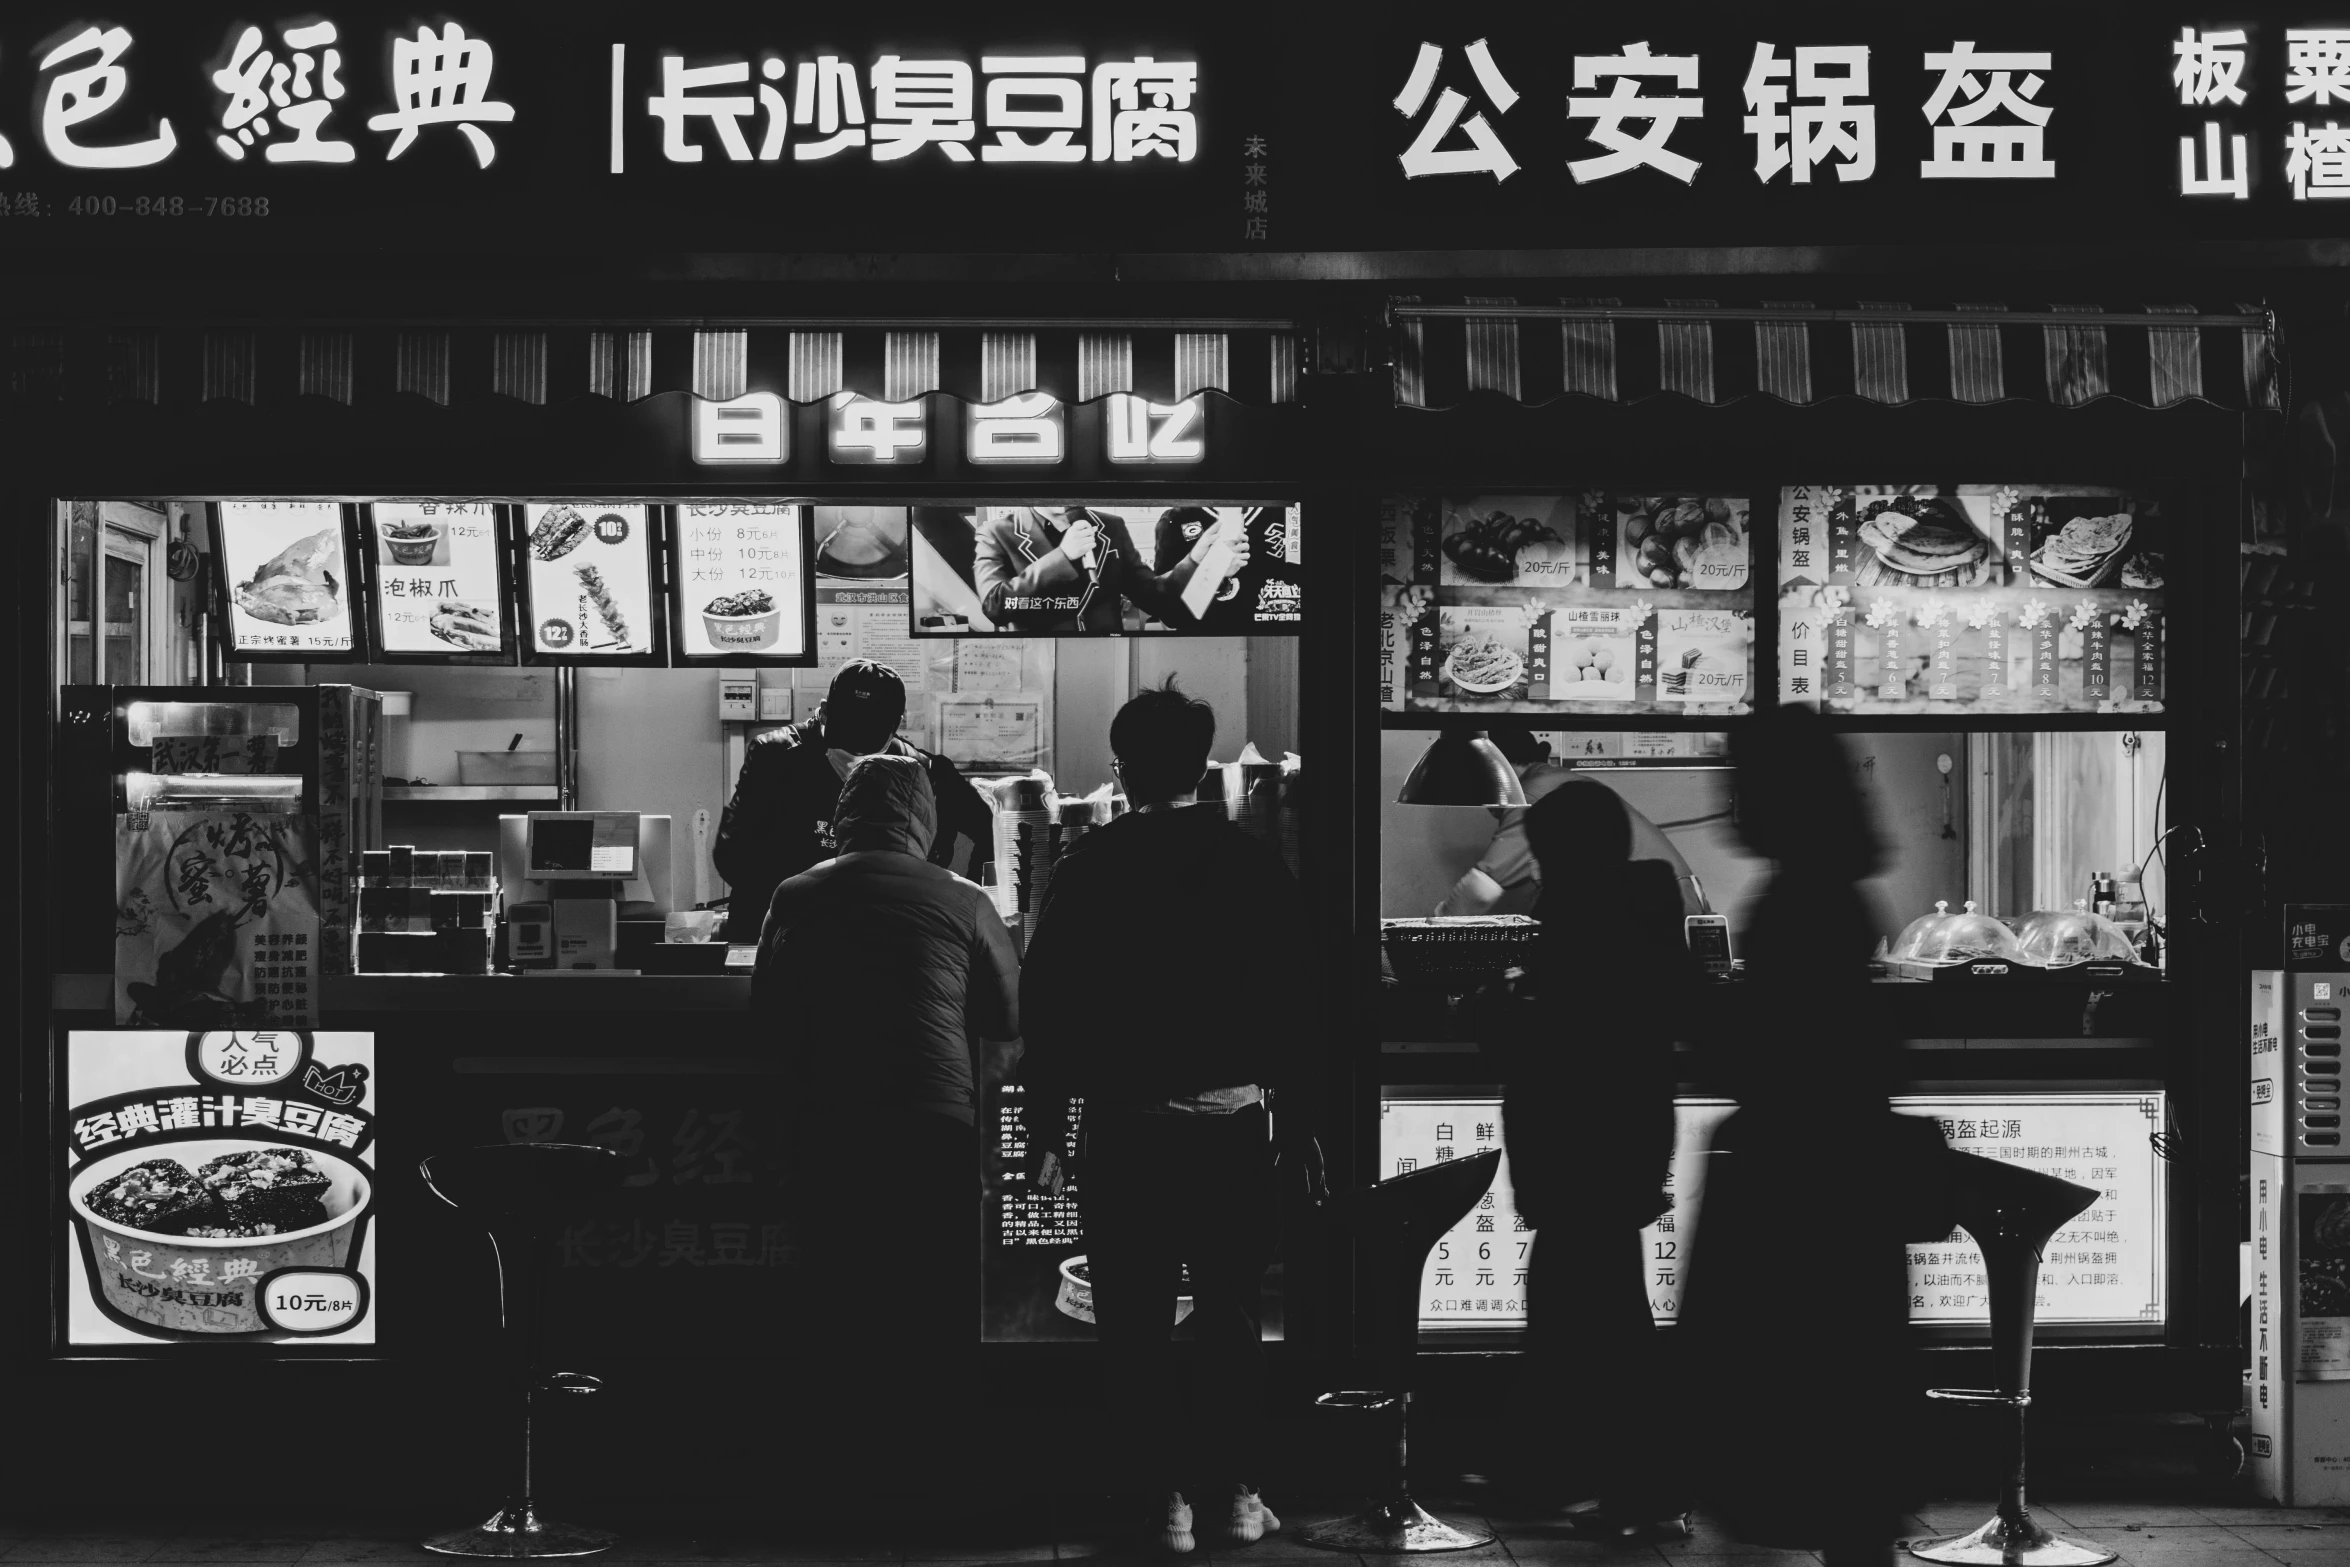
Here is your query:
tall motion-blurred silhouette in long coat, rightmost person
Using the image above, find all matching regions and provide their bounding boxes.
[1680,707,1955,1567]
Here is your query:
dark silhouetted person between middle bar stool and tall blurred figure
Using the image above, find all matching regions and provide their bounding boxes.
[1492,780,1697,1536]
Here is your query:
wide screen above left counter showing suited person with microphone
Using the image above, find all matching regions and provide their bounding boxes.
[912,503,1304,637]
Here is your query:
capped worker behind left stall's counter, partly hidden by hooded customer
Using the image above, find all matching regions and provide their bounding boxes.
[710,658,994,944]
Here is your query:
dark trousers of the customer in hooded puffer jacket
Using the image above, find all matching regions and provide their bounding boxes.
[792,1107,980,1497]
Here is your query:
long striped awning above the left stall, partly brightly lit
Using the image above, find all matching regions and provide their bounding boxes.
[0,320,1307,406]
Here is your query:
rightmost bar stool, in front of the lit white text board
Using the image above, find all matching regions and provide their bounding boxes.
[1911,1154,2115,1567]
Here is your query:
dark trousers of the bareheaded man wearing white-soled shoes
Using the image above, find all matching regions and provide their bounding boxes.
[1079,1107,1274,1525]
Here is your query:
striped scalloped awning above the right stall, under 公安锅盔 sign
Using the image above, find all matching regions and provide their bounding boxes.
[1389,296,2280,409]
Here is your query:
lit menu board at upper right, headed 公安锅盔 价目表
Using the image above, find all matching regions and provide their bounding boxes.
[1779,484,2167,714]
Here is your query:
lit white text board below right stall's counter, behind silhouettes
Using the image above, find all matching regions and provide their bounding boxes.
[1379,1090,2167,1330]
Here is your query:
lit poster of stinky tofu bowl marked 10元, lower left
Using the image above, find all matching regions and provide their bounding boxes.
[56,1029,376,1351]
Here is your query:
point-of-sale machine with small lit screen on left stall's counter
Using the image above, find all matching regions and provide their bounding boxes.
[498,811,670,973]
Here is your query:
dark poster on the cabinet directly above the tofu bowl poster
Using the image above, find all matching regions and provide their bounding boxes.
[115,811,320,1029]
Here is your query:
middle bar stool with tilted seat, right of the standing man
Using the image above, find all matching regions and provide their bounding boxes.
[1300,1149,1502,1553]
